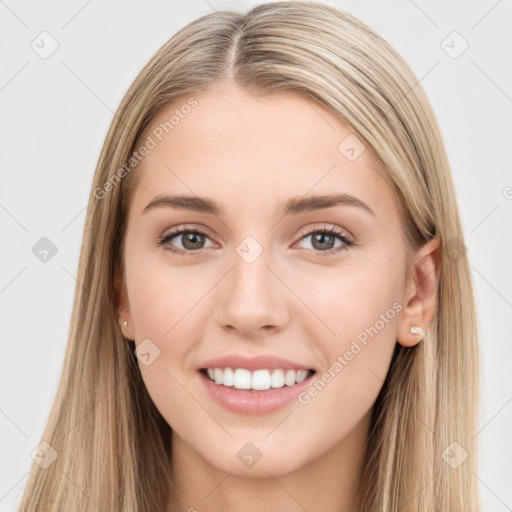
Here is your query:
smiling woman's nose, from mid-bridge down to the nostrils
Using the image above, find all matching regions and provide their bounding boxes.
[215,246,289,338]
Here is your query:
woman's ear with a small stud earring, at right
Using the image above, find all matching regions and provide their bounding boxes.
[397,237,441,347]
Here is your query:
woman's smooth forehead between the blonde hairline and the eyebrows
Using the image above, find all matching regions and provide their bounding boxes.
[127,86,396,221]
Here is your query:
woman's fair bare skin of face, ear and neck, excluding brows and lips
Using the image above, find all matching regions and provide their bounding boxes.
[117,84,439,512]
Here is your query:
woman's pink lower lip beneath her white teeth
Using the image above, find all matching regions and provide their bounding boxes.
[198,371,314,415]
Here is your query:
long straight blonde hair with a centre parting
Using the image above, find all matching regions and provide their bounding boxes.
[20,1,480,512]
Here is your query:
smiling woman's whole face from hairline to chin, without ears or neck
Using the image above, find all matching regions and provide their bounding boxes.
[122,82,407,476]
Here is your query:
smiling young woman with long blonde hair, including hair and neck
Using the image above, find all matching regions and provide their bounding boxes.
[21,2,480,512]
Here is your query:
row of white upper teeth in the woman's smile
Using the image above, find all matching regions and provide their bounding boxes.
[203,368,309,391]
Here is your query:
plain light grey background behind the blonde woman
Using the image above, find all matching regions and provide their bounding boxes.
[0,0,512,512]
